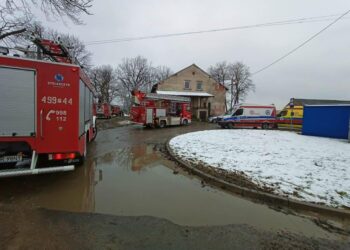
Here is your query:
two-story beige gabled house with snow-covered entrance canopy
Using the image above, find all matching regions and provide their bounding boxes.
[152,64,227,120]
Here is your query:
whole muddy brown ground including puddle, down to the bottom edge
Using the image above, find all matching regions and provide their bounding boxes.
[0,122,349,249]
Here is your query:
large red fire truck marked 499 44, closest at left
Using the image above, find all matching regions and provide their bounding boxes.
[0,39,97,177]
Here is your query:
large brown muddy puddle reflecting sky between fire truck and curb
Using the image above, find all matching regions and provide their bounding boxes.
[0,123,350,242]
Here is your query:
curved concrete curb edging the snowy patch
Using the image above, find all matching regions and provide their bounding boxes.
[166,138,350,219]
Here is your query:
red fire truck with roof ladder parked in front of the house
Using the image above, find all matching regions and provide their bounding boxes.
[130,91,192,128]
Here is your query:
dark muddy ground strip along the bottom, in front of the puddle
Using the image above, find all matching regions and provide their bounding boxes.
[0,205,350,249]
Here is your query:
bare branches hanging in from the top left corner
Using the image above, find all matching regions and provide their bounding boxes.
[2,0,93,24]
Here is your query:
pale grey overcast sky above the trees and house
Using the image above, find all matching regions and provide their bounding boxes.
[42,0,350,108]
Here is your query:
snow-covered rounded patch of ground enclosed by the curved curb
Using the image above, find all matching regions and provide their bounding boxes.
[170,129,350,207]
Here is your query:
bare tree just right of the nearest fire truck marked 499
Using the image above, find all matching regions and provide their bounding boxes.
[89,65,118,103]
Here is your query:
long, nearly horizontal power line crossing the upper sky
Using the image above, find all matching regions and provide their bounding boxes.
[86,14,348,46]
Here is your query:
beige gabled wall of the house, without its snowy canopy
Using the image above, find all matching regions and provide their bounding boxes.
[157,64,226,118]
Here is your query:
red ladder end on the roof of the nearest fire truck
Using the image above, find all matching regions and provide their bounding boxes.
[32,38,73,64]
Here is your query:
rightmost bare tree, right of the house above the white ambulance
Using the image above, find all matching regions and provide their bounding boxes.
[228,62,255,108]
